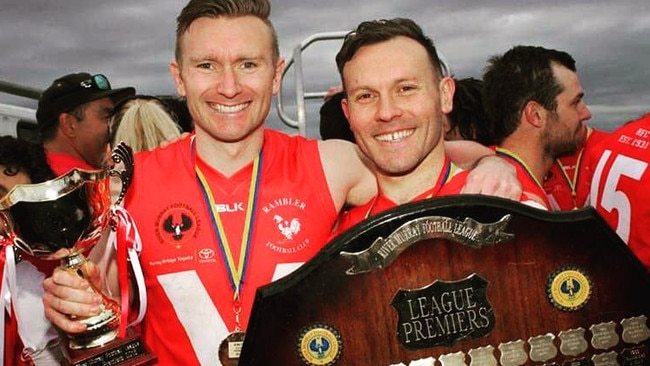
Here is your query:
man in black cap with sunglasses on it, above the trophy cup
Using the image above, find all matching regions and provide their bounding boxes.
[36,72,135,175]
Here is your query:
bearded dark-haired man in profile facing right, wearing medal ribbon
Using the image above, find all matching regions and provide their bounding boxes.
[483,46,591,209]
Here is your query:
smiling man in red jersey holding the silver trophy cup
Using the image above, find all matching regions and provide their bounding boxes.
[44,0,516,365]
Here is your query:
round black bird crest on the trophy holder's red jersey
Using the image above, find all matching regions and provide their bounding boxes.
[156,203,199,248]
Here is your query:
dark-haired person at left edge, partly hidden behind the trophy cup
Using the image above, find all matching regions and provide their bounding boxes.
[0,136,62,365]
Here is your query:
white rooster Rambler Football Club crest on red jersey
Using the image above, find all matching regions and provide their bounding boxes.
[260,197,309,254]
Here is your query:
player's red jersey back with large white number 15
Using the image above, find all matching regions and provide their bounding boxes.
[584,114,650,269]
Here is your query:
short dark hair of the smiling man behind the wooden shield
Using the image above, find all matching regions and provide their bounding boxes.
[336,18,442,84]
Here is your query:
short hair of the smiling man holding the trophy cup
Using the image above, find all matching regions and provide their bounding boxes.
[175,0,280,62]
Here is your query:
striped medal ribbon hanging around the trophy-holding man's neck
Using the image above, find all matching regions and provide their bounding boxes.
[194,146,262,306]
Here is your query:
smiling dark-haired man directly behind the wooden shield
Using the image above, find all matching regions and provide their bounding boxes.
[336,18,474,232]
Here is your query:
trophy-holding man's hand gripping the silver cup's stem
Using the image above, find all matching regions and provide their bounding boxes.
[43,262,102,333]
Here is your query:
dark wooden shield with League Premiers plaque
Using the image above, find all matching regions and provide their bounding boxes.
[240,196,650,366]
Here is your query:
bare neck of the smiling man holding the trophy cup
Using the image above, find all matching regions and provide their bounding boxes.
[196,129,264,177]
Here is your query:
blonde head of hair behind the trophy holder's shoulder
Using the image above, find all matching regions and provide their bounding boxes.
[109,95,181,152]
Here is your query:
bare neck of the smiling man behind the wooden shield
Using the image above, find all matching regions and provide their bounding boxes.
[377,149,445,205]
